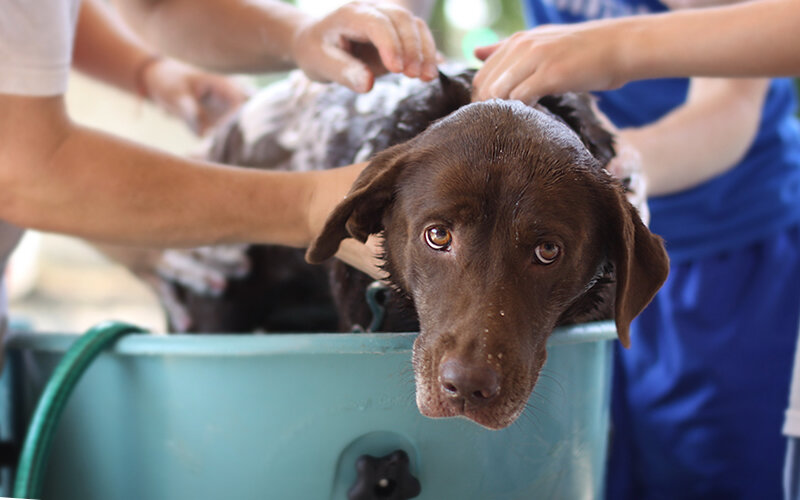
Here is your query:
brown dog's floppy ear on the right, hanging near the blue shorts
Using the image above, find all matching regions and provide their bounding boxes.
[604,185,669,347]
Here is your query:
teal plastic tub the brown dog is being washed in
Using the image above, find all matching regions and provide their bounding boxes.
[4,322,615,500]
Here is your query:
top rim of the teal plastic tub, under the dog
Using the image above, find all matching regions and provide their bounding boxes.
[6,321,617,356]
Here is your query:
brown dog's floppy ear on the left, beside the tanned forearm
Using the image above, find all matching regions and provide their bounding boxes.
[306,143,407,264]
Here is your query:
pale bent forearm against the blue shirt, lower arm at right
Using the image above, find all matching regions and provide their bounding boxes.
[619,79,768,195]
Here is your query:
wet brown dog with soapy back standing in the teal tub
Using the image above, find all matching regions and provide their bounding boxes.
[147,72,668,429]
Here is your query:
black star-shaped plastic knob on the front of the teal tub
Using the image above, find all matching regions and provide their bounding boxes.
[347,450,422,500]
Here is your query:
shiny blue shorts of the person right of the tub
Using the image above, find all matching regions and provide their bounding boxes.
[606,227,800,500]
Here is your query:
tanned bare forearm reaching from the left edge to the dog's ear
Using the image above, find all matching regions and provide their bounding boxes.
[0,127,310,247]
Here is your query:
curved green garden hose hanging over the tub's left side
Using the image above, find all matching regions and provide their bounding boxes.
[14,322,145,498]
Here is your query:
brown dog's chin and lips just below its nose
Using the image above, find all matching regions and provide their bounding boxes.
[417,382,525,431]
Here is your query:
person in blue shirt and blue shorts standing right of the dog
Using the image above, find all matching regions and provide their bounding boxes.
[476,0,800,500]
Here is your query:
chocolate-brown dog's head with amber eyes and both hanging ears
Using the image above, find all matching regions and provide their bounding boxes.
[307,101,667,429]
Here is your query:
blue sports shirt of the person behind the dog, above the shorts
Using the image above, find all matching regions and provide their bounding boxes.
[524,0,800,262]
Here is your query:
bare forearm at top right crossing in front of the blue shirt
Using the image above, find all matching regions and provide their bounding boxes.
[624,0,800,81]
